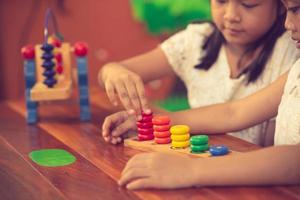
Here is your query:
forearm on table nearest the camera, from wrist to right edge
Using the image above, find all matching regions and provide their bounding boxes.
[197,144,300,185]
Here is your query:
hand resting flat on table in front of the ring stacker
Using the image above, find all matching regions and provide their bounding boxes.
[119,153,199,190]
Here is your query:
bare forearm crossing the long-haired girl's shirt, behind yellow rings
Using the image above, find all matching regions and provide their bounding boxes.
[169,73,288,133]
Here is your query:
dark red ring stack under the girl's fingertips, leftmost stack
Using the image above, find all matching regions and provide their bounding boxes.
[136,112,154,141]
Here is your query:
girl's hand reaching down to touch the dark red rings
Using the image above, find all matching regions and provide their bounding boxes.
[101,63,150,115]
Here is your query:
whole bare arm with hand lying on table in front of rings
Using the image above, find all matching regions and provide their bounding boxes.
[119,144,300,189]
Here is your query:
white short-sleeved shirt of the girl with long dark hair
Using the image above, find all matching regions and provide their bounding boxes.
[161,23,300,144]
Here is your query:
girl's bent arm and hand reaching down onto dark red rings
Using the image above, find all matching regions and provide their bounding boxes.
[98,47,173,113]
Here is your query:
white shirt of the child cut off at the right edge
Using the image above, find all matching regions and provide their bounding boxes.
[274,59,300,145]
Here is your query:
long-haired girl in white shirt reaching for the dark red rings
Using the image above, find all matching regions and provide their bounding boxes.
[99,0,298,145]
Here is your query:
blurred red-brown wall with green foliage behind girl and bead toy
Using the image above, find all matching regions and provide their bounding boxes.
[0,0,210,110]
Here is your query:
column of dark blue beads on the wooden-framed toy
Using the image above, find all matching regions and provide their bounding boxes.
[41,43,57,88]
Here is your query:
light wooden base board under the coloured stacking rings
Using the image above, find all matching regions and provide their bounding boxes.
[124,137,233,158]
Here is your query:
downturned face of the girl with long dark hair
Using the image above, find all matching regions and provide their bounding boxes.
[211,0,278,46]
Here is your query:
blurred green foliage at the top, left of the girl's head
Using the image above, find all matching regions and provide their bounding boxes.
[131,0,211,35]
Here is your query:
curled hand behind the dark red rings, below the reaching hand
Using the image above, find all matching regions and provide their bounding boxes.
[102,111,136,144]
